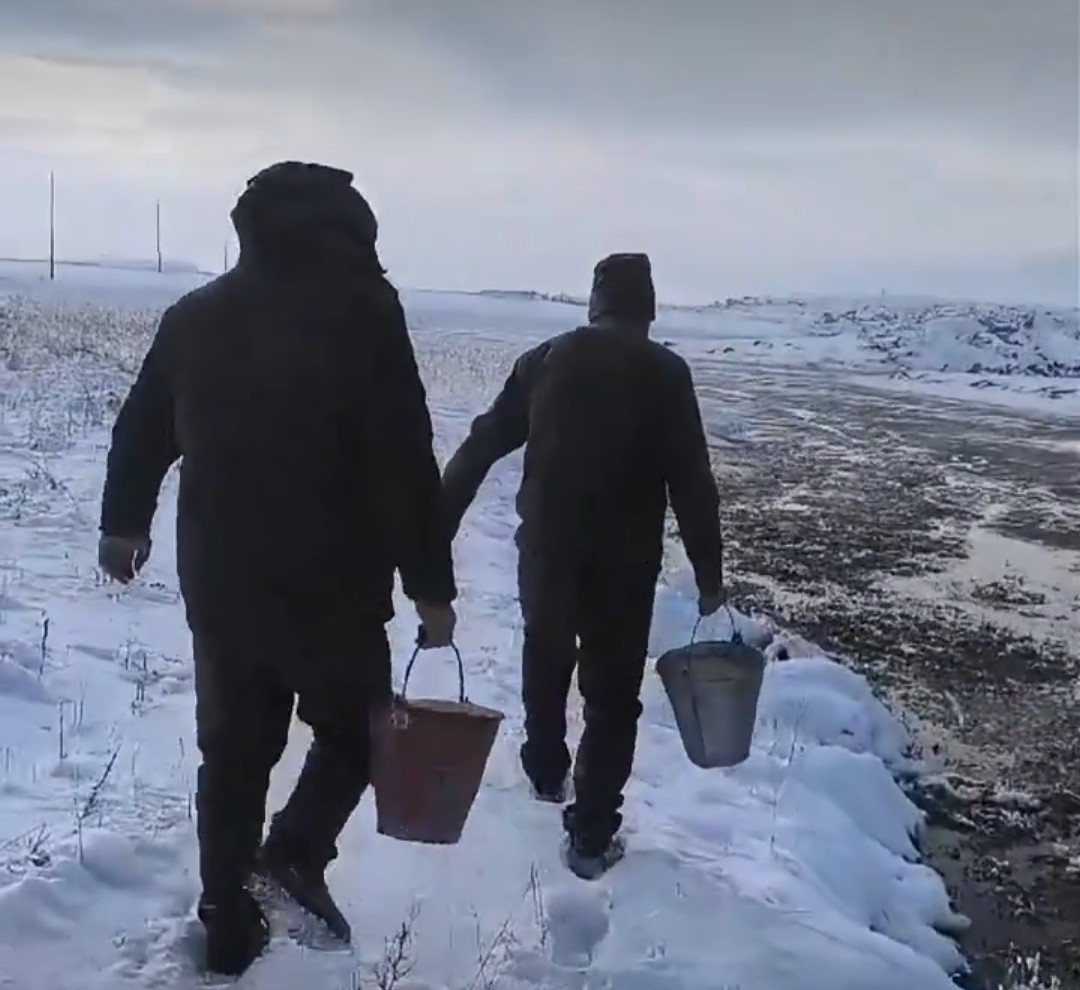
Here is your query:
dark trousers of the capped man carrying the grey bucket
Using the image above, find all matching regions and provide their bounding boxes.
[518,547,657,847]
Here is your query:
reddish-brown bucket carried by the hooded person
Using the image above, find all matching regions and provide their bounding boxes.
[374,647,503,845]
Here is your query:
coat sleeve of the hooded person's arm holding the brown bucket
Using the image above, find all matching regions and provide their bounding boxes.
[367,298,457,605]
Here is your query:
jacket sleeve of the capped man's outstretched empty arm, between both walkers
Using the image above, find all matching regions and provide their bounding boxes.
[443,343,549,535]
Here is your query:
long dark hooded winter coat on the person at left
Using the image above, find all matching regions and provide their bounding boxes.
[102,163,456,628]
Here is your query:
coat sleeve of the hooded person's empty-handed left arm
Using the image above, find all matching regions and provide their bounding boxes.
[100,311,180,537]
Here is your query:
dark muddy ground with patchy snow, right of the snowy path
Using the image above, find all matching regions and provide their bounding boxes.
[696,365,1080,990]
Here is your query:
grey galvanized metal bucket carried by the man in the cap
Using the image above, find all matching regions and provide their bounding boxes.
[657,604,766,769]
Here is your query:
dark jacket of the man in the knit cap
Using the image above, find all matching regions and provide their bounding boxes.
[443,321,723,593]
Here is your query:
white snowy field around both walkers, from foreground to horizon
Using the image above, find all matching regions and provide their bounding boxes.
[0,268,1062,990]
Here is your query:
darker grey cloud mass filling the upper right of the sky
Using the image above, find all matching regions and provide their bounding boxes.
[356,0,1080,147]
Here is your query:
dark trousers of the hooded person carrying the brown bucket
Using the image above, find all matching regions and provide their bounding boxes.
[194,616,390,901]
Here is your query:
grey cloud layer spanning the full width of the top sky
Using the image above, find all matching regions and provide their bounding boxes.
[6,0,1080,146]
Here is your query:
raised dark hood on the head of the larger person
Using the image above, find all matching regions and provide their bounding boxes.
[232,162,383,273]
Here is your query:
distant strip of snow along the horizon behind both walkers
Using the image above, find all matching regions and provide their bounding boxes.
[0,262,1080,416]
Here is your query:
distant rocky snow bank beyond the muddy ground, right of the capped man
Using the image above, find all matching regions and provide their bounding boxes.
[657,299,1080,416]
